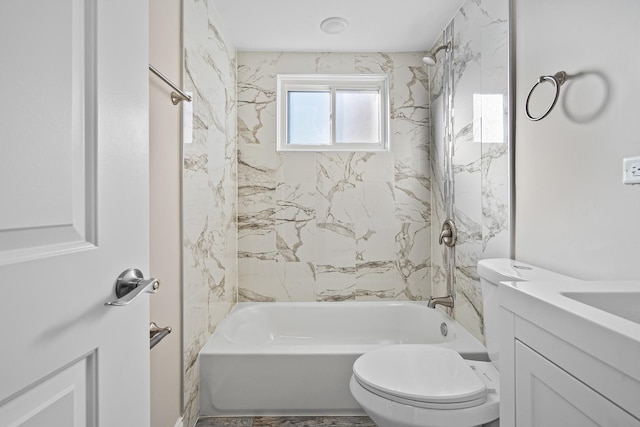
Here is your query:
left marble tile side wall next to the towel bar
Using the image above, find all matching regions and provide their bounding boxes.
[183,0,237,426]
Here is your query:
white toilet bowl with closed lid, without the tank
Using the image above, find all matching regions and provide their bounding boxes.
[349,344,500,427]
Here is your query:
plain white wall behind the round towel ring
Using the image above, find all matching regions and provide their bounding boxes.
[513,0,640,279]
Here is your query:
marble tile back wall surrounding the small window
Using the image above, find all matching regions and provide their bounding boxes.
[238,52,431,301]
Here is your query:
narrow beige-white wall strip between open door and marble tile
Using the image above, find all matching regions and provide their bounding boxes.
[145,0,182,427]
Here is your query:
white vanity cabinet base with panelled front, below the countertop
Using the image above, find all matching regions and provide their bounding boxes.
[499,282,640,427]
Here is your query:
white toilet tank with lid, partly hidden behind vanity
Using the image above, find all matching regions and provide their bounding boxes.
[478,258,578,369]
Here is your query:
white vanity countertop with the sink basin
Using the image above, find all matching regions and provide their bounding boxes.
[499,281,640,381]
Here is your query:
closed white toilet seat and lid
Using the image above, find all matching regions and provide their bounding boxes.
[353,344,499,410]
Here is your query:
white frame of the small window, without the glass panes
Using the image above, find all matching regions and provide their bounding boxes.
[276,74,391,152]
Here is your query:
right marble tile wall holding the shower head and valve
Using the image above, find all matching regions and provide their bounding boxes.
[431,0,511,339]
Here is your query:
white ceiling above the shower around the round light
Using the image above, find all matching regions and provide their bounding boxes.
[213,0,465,52]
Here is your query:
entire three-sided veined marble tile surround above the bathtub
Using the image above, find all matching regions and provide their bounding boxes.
[183,0,510,425]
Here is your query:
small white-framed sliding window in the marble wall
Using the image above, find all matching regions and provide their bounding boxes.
[277,74,389,151]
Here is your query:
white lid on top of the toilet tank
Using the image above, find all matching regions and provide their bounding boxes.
[478,258,578,283]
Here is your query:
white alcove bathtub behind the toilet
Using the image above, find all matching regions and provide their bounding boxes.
[200,302,487,416]
